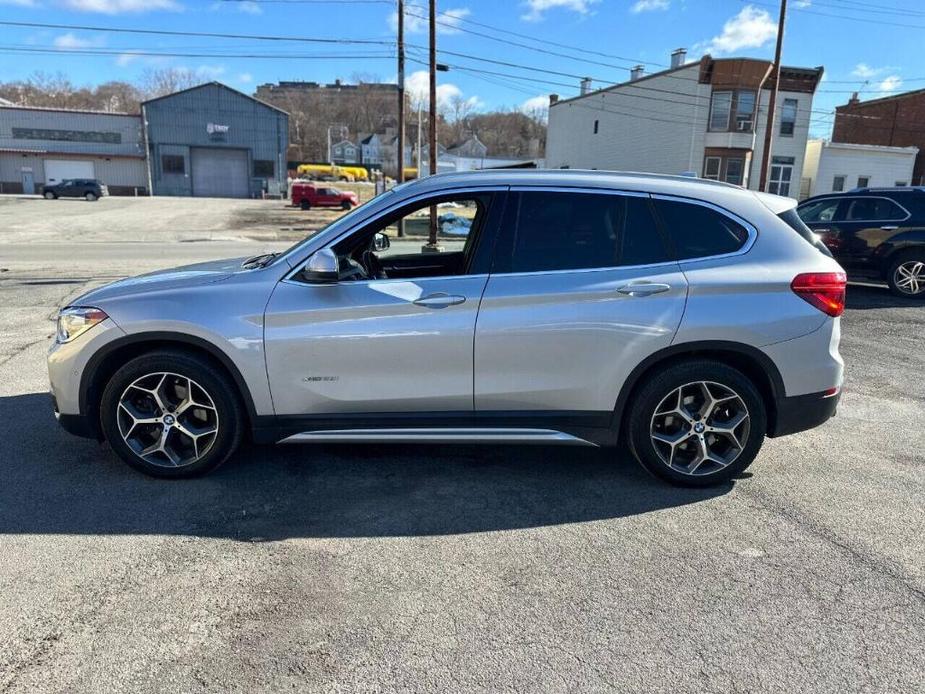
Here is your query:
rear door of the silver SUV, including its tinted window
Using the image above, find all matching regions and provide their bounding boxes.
[475,188,687,417]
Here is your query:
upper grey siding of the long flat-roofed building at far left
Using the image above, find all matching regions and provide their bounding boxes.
[0,107,144,156]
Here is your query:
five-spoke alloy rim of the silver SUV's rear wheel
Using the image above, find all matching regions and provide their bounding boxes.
[649,381,750,476]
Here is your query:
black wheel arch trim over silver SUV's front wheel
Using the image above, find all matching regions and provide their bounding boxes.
[80,333,257,438]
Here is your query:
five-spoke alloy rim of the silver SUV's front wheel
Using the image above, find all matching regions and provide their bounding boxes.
[116,372,219,468]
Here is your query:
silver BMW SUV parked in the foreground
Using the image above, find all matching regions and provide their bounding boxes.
[48,171,845,485]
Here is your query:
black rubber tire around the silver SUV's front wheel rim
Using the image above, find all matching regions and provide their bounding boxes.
[100,351,246,478]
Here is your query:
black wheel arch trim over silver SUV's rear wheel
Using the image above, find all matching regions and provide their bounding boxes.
[612,340,785,437]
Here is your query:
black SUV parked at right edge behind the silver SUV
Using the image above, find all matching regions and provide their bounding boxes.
[797,186,925,299]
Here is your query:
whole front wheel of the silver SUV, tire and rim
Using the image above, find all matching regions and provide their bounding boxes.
[100,352,244,478]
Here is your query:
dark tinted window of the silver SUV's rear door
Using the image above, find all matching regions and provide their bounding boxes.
[501,192,667,272]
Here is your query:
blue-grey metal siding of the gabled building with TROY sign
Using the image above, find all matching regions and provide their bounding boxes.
[144,84,289,195]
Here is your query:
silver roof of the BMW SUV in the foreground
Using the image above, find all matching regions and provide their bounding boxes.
[400,169,796,214]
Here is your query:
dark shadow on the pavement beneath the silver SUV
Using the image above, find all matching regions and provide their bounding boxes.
[0,393,732,541]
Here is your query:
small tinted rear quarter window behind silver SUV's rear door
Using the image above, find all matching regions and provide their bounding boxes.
[654,200,748,259]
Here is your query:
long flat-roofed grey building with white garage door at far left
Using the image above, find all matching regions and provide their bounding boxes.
[0,105,148,195]
